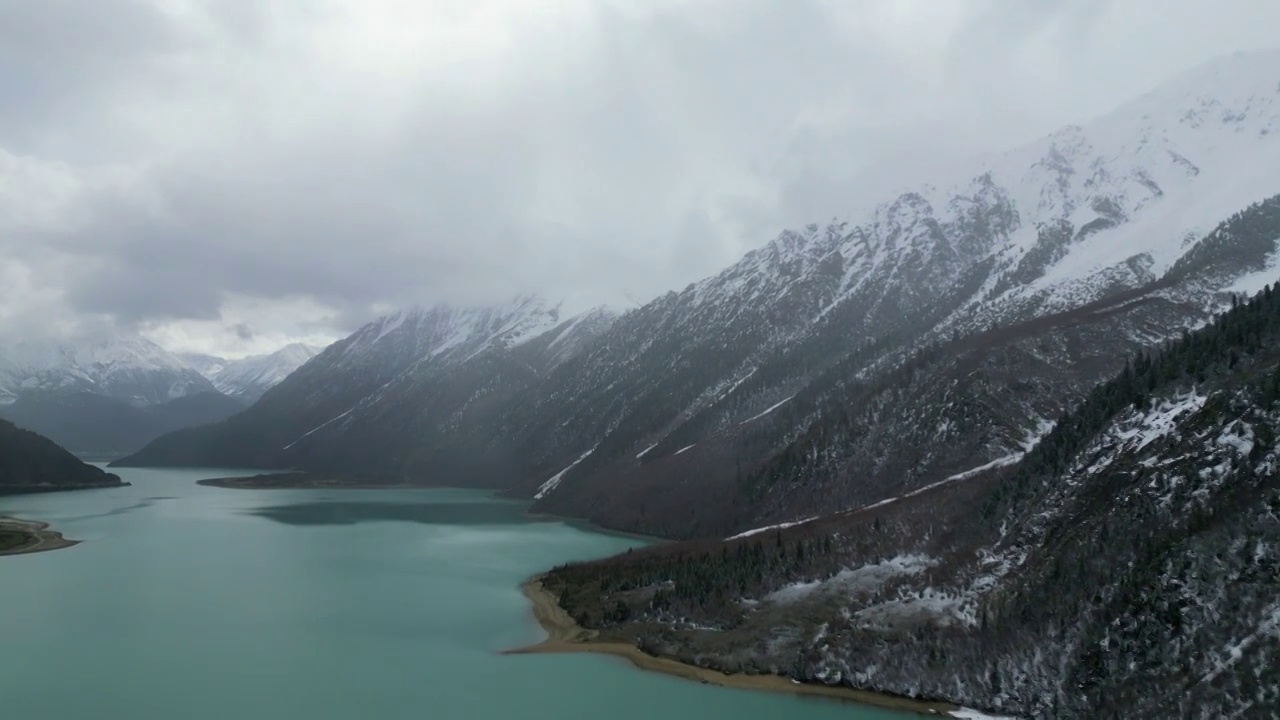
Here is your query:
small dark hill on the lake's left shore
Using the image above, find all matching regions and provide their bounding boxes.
[0,420,123,495]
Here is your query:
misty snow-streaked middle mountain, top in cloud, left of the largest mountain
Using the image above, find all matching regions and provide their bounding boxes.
[117,296,613,473]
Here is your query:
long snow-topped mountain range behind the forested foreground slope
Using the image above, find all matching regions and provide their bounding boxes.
[124,53,1280,537]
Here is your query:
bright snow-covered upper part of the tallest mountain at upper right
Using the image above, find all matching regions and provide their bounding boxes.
[778,51,1280,335]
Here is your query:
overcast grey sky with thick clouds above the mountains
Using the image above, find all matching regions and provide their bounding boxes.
[0,0,1280,355]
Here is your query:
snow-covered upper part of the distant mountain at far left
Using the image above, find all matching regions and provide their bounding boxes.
[0,336,216,407]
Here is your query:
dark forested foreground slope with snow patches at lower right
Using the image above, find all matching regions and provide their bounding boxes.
[544,287,1280,719]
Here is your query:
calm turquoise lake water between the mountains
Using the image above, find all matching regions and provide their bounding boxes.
[0,469,915,720]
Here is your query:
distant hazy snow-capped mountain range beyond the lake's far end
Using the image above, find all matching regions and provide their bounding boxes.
[0,336,325,459]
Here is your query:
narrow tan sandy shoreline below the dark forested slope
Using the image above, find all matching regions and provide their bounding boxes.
[503,578,959,716]
